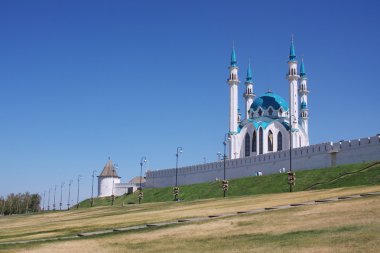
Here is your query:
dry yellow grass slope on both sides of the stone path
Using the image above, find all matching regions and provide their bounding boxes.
[0,186,380,252]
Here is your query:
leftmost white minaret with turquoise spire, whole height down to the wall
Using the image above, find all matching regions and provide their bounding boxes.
[227,47,240,158]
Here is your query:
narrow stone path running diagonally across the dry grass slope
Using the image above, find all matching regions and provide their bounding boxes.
[0,192,380,245]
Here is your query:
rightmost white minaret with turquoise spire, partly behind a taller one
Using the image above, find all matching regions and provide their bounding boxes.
[298,58,309,135]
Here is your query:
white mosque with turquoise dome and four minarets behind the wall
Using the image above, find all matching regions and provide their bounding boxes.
[227,38,309,159]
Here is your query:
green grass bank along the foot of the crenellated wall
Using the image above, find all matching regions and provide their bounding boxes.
[80,162,380,207]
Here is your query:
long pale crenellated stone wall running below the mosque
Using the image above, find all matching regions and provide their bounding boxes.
[146,136,380,188]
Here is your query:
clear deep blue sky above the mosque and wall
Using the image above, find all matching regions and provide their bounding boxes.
[0,0,380,205]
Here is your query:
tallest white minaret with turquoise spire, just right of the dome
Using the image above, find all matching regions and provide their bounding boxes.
[286,35,300,136]
